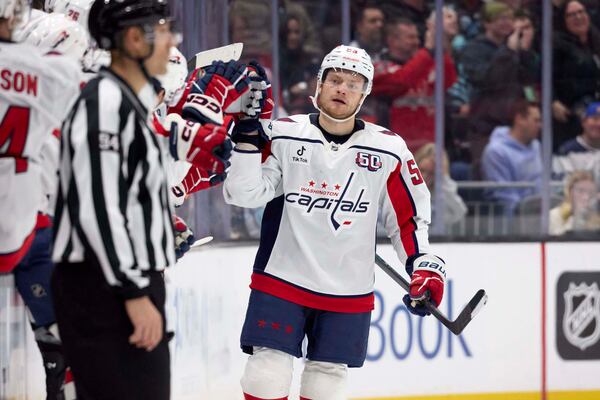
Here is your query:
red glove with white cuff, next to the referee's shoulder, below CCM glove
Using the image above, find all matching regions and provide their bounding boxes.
[165,113,232,175]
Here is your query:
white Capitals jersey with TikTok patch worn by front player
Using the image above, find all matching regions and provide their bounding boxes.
[224,114,431,312]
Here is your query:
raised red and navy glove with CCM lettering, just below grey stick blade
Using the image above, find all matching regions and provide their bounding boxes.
[182,61,250,123]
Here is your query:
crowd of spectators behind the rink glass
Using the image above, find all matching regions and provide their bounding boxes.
[220,0,600,237]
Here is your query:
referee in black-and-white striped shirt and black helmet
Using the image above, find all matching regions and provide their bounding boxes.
[52,0,176,400]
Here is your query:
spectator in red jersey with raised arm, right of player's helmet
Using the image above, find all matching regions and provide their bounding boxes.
[371,14,457,151]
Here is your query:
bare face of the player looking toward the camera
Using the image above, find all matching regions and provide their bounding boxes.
[318,70,366,119]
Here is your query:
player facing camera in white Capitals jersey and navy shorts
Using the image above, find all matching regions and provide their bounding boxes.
[224,46,445,400]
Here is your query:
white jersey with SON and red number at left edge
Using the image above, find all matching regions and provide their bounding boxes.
[0,41,79,254]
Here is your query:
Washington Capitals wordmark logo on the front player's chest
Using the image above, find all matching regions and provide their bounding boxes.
[285,172,371,235]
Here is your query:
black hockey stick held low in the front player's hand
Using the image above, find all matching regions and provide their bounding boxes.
[375,254,487,335]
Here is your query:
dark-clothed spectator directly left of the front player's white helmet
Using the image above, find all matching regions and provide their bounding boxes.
[279,13,321,113]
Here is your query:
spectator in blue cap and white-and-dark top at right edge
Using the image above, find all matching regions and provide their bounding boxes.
[552,102,600,182]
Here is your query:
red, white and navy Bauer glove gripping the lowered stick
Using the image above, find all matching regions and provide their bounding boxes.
[402,254,446,317]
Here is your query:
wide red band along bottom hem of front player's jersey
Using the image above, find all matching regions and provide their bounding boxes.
[250,273,375,313]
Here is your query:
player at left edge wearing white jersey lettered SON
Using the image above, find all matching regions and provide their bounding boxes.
[0,0,85,400]
